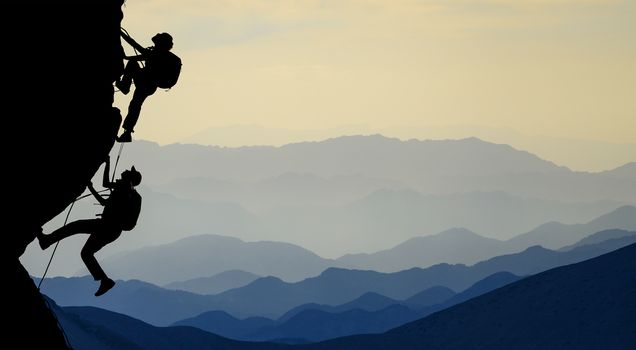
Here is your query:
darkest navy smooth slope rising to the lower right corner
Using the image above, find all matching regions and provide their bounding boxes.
[304,244,636,350]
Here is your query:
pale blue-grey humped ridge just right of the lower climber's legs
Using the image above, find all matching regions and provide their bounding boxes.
[103,235,339,285]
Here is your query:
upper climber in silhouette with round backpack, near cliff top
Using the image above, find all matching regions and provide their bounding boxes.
[115,30,181,142]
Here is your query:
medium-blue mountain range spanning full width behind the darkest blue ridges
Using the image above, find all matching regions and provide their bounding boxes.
[42,231,636,325]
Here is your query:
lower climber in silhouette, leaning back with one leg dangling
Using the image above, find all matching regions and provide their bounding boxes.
[37,158,141,296]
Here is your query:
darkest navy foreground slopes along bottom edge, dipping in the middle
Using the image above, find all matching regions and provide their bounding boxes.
[51,244,636,350]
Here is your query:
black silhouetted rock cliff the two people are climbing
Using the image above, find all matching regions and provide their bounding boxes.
[7,0,124,348]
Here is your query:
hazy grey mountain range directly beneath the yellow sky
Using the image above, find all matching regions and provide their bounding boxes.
[117,135,636,201]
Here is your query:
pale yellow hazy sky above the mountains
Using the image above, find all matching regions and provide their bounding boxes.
[117,0,636,170]
